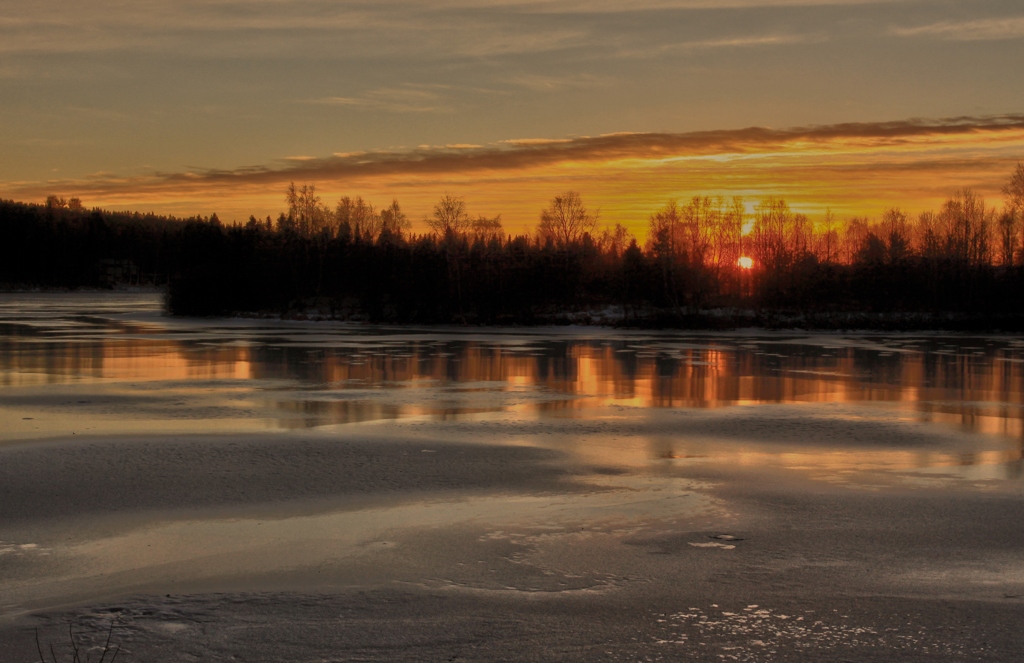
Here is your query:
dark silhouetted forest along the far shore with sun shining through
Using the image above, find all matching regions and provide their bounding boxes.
[6,164,1024,329]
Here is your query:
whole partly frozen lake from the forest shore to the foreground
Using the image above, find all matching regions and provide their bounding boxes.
[0,293,1024,663]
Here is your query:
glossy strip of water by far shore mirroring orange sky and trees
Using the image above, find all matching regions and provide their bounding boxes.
[0,293,1024,485]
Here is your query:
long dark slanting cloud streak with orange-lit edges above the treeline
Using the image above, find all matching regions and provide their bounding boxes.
[14,114,1024,196]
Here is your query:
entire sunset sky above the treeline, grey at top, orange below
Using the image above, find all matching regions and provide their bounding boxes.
[0,0,1024,234]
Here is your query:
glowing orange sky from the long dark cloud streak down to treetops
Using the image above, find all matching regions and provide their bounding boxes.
[12,115,1024,237]
